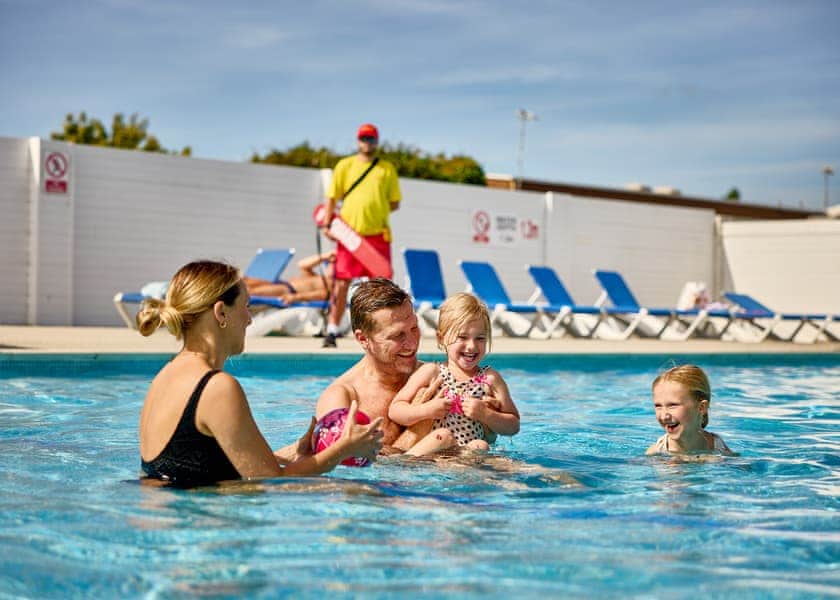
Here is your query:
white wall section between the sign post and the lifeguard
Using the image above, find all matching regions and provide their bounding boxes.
[66,147,320,325]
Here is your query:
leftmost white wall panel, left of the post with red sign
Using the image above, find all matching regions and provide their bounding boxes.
[0,137,31,323]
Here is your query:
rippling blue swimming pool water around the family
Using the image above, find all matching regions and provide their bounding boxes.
[0,355,840,598]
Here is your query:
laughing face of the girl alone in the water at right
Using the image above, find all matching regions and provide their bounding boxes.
[653,381,709,449]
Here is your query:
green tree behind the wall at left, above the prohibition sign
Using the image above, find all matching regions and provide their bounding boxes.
[50,111,192,156]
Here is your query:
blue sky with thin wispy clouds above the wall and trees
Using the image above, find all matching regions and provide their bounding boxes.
[0,0,840,210]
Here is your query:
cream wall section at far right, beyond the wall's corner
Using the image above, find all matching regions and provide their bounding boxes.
[722,219,840,314]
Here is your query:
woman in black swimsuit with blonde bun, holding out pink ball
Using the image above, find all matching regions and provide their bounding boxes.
[137,261,382,486]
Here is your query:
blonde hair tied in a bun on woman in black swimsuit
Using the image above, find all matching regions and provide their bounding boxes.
[137,260,242,339]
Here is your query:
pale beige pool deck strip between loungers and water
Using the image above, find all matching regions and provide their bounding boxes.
[0,325,840,354]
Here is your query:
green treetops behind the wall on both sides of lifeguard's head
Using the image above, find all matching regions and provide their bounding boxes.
[251,142,487,185]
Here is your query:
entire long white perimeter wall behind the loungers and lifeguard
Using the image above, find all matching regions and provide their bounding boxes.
[8,138,828,325]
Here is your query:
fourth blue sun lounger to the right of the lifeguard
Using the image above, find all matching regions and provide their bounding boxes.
[593,269,734,341]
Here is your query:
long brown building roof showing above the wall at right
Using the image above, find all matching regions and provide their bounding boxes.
[487,174,825,219]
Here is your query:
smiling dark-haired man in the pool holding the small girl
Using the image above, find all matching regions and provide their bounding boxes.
[315,278,441,453]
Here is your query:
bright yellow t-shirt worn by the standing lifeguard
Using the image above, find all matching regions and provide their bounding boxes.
[328,154,401,240]
